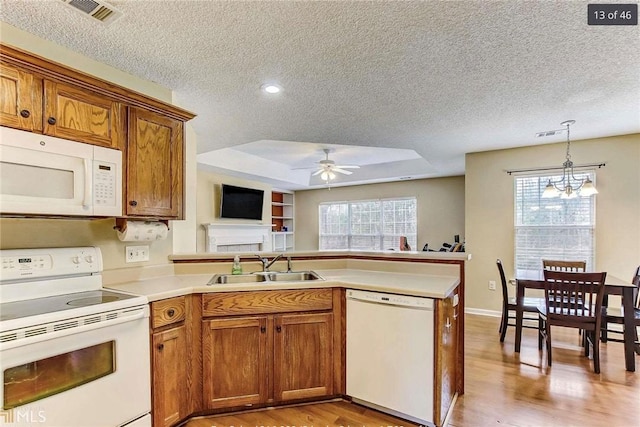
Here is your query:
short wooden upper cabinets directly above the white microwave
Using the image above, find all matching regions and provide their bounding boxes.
[0,64,124,149]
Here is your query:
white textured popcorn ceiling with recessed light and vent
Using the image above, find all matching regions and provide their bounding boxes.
[0,0,640,188]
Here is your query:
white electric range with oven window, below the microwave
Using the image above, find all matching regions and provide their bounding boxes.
[0,247,151,427]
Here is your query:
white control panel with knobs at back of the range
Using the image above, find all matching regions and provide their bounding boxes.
[0,247,102,282]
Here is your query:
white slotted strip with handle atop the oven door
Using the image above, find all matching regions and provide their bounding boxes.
[0,305,149,352]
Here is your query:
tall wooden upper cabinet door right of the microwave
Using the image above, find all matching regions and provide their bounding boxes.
[126,108,184,219]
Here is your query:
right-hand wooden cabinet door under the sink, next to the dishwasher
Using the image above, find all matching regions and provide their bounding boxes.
[274,313,333,401]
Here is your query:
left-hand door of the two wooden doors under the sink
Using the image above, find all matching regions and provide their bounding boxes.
[202,316,271,409]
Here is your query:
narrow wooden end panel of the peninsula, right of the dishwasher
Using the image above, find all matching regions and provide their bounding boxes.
[434,290,459,425]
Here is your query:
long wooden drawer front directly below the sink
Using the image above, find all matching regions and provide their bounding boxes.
[202,289,333,316]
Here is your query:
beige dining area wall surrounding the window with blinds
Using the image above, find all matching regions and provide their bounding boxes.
[465,134,640,310]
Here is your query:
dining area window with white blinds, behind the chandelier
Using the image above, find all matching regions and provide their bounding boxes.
[514,171,595,279]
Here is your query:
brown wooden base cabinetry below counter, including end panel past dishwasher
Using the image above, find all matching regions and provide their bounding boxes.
[151,288,461,427]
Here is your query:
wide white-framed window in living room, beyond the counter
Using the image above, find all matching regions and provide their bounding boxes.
[318,197,418,250]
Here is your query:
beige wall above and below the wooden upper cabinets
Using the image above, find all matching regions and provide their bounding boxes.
[0,23,191,270]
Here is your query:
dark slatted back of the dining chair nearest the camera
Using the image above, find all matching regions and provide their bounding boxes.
[544,270,607,324]
